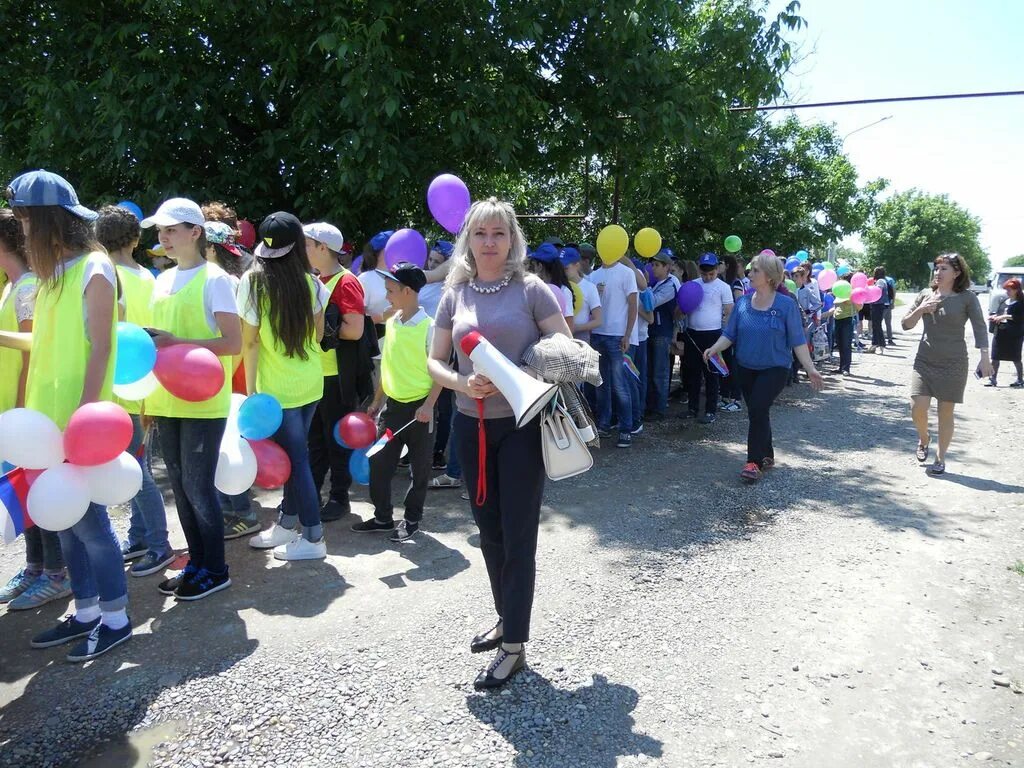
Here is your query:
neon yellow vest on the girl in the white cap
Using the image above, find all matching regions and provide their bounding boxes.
[145,262,231,419]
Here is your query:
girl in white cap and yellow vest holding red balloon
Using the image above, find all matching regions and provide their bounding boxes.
[142,198,242,601]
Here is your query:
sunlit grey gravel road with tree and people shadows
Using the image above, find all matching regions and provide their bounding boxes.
[0,303,1024,768]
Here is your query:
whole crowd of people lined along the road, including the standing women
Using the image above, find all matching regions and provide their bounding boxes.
[0,171,1022,688]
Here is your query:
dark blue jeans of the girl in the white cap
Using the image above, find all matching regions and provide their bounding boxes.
[157,416,227,573]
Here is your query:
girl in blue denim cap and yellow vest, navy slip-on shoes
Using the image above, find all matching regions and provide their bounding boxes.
[0,171,132,662]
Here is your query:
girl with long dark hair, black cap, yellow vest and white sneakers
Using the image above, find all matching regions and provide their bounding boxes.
[239,211,331,560]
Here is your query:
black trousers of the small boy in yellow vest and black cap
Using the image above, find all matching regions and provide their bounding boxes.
[370,397,434,522]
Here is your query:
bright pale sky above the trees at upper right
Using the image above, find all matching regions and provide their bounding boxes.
[768,0,1024,266]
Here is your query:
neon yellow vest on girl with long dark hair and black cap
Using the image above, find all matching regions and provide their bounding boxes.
[256,274,324,408]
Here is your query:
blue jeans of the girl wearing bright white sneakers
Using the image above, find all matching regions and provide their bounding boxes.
[273,402,324,542]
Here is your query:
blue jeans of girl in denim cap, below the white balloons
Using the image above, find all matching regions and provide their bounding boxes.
[60,504,128,610]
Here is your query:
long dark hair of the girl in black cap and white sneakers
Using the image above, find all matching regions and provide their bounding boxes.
[249,239,314,360]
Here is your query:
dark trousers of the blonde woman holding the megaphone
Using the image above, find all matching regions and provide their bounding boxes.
[455,413,545,643]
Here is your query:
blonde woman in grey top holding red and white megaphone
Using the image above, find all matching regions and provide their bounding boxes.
[429,198,570,689]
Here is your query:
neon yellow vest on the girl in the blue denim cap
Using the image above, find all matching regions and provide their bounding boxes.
[25,253,118,429]
